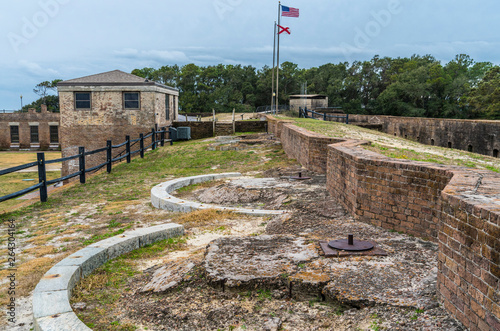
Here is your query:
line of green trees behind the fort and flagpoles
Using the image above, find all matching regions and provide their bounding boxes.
[24,54,500,119]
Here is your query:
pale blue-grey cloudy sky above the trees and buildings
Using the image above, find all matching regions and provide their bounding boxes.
[0,0,500,110]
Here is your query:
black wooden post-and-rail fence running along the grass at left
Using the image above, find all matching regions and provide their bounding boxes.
[0,128,172,202]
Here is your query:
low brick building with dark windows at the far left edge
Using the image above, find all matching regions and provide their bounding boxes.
[0,105,59,151]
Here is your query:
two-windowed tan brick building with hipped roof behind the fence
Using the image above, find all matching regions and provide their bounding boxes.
[57,70,179,176]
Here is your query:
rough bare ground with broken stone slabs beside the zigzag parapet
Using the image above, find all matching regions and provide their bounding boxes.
[73,163,464,330]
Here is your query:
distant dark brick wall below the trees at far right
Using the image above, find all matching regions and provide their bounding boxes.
[349,115,500,157]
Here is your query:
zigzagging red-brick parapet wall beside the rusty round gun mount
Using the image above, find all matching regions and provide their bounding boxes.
[269,117,500,330]
